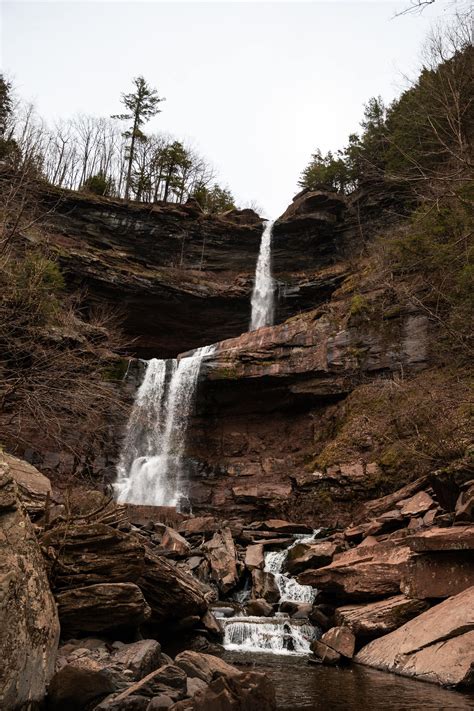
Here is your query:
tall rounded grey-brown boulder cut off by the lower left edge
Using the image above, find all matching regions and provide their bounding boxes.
[0,460,59,711]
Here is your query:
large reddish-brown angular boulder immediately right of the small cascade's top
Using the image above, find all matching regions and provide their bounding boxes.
[298,541,411,602]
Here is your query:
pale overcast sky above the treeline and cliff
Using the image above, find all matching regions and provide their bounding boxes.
[1,0,452,217]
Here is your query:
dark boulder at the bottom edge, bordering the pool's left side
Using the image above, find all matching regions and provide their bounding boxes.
[192,671,276,711]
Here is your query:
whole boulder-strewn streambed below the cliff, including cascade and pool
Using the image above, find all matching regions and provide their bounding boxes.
[0,456,474,711]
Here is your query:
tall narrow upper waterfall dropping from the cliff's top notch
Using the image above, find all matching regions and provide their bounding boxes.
[250,221,275,331]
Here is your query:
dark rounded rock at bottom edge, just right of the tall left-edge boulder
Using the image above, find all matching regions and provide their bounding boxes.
[48,664,116,711]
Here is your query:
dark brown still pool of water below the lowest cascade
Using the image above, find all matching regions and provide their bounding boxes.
[224,652,474,711]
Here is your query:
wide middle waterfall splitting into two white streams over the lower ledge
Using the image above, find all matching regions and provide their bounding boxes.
[114,346,214,506]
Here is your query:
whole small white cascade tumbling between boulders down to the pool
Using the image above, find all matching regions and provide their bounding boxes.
[219,531,318,654]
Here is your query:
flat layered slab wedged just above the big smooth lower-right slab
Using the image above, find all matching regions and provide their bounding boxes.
[334,595,428,643]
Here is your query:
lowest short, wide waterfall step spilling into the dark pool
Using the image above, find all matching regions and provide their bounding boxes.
[219,616,316,654]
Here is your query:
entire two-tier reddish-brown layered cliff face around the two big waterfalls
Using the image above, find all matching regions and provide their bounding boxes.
[19,186,457,524]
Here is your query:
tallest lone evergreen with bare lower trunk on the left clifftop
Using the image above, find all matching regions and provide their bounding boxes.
[112,76,164,200]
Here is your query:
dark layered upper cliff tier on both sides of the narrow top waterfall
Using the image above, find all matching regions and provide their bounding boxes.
[43,193,350,358]
